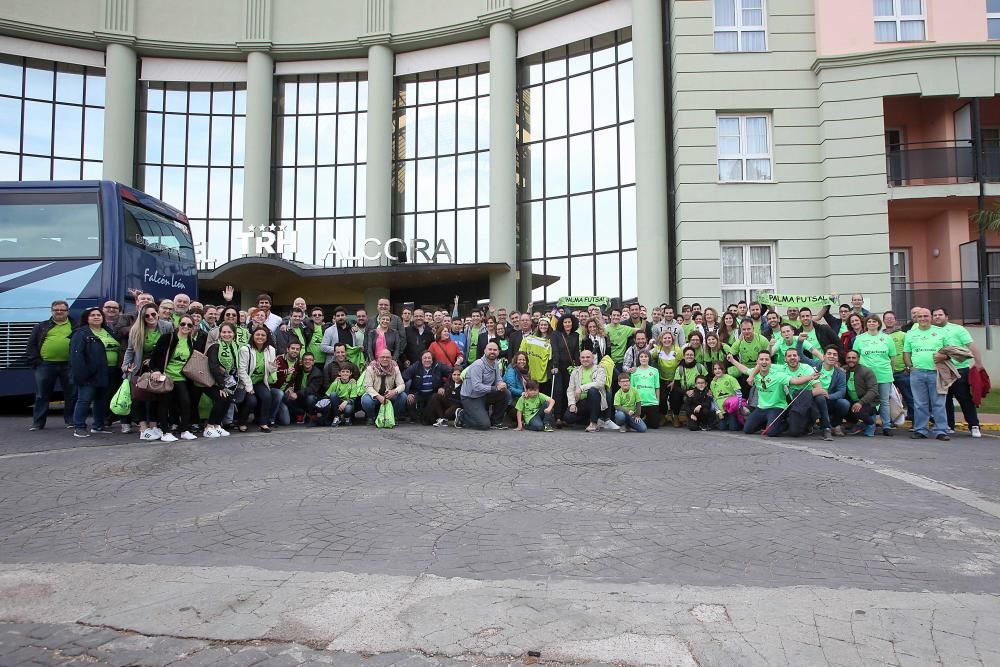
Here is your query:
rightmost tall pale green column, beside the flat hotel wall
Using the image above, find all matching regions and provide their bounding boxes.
[632,0,673,308]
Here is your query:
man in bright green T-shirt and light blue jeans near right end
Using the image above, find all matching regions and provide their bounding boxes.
[904,308,951,440]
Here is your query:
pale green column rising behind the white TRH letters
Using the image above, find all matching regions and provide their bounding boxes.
[243,51,274,240]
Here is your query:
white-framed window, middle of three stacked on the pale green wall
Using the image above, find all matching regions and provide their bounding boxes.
[717,114,773,182]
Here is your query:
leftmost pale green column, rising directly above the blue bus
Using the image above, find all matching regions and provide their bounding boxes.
[103,44,137,185]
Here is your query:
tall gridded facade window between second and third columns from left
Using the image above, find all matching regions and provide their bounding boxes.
[271,74,368,266]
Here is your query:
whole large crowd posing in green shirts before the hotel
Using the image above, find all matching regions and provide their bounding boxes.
[27,288,982,442]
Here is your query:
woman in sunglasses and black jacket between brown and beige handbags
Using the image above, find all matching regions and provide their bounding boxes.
[149,315,198,442]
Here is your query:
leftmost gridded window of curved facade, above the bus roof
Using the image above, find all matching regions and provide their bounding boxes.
[0,55,104,181]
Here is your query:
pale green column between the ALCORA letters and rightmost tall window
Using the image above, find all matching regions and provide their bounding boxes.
[490,22,516,309]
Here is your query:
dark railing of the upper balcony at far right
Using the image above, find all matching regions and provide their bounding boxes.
[886,141,1000,186]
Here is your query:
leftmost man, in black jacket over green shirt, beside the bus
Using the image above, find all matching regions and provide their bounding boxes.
[24,301,76,431]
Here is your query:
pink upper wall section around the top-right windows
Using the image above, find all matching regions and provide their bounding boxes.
[816,0,987,57]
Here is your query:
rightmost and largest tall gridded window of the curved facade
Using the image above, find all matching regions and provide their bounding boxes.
[517,29,636,303]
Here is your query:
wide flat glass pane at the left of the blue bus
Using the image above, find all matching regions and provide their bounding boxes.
[0,192,101,260]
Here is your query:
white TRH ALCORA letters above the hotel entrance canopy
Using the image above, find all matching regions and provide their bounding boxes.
[236,225,455,263]
